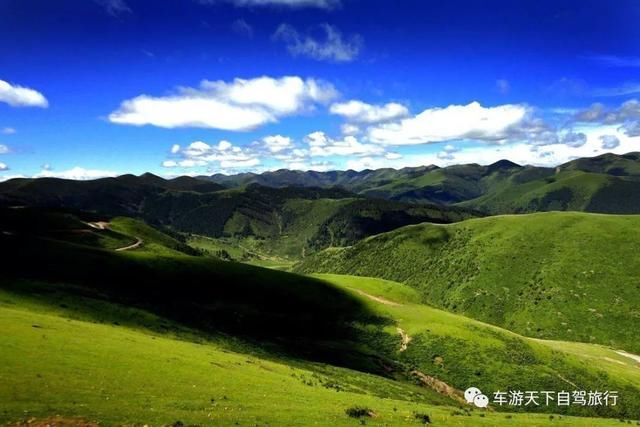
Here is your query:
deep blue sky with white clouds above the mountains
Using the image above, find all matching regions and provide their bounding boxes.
[0,0,640,179]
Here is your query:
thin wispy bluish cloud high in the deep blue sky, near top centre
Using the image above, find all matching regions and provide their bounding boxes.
[272,24,364,62]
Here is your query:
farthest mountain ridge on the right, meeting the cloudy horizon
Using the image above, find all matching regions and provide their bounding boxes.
[200,152,640,214]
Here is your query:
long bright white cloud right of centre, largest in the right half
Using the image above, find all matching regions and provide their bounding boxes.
[368,102,529,145]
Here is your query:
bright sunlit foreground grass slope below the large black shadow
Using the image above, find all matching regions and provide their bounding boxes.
[0,291,632,426]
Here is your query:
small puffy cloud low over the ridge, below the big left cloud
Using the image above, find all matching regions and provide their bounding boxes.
[162,140,260,169]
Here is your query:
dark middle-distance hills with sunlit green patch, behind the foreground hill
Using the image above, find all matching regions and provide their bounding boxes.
[0,174,477,259]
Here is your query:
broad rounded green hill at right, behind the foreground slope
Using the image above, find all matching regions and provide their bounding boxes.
[296,213,640,353]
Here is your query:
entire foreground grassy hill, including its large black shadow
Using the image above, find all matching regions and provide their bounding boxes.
[0,210,640,426]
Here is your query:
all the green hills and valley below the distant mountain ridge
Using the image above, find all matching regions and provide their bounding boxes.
[0,152,640,426]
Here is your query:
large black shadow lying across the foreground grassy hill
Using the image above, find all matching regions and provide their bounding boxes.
[0,234,389,372]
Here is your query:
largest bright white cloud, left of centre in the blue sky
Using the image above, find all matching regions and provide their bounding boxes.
[109,76,337,131]
